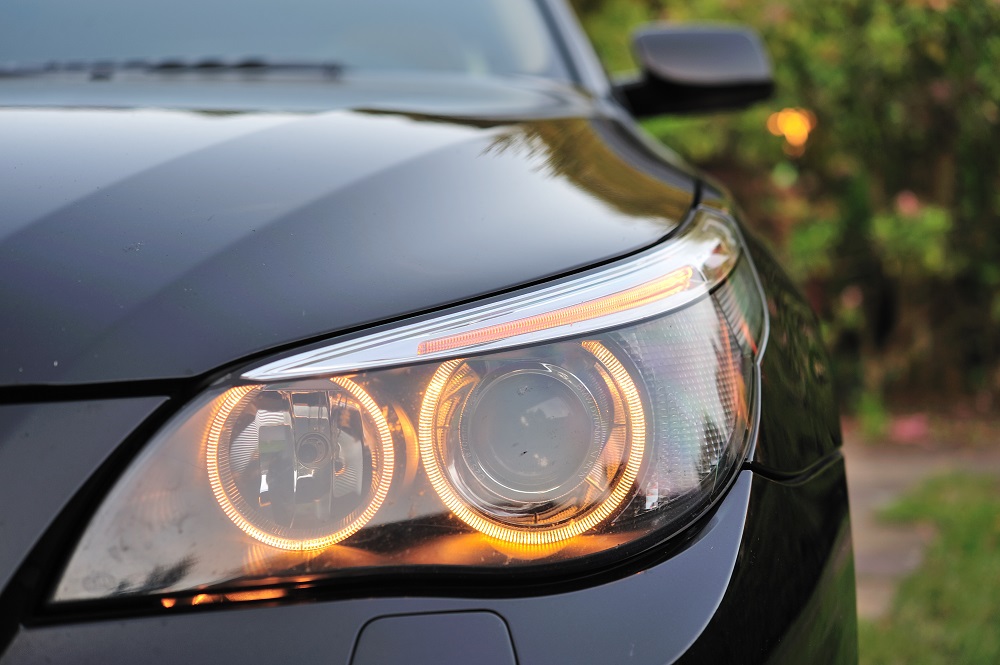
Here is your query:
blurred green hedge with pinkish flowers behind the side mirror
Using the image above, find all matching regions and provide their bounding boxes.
[573,0,1000,416]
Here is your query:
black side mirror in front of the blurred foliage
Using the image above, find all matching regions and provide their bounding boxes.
[615,25,774,117]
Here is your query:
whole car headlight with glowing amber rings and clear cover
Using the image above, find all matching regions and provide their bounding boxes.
[53,209,766,607]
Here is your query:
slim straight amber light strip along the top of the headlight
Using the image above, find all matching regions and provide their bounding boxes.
[417,266,694,355]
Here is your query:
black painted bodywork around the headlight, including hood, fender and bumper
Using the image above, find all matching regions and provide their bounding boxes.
[0,0,857,665]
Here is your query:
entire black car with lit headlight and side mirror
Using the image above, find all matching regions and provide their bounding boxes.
[0,0,857,665]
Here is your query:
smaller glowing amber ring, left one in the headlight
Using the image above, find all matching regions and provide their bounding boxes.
[205,377,395,551]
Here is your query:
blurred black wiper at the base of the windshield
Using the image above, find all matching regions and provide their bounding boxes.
[0,57,344,80]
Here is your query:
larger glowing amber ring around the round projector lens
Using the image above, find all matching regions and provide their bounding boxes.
[418,341,646,546]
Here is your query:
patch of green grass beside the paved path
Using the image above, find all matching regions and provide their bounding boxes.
[859,474,1000,665]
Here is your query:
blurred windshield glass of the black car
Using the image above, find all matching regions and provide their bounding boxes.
[0,0,565,78]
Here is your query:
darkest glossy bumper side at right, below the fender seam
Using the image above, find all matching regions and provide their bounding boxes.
[678,460,858,665]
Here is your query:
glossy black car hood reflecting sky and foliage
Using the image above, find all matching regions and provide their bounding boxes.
[0,96,694,386]
